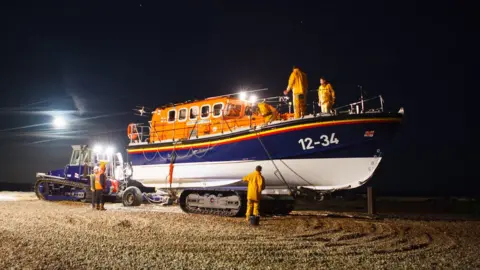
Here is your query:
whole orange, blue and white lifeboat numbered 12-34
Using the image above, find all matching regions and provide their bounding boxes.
[127,92,403,216]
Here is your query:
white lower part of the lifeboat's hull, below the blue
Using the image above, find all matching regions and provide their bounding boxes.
[129,156,381,190]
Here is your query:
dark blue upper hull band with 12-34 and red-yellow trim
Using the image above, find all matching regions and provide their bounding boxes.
[129,115,400,166]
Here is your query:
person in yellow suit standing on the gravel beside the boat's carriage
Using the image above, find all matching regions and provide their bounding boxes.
[242,166,265,222]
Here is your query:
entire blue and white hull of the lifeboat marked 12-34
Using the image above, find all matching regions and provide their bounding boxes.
[128,115,401,190]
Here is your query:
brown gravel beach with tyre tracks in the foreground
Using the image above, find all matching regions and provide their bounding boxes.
[0,195,480,269]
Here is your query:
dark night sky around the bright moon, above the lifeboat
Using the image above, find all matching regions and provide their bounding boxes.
[0,0,472,195]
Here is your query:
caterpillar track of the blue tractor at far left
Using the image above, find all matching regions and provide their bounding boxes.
[34,178,92,201]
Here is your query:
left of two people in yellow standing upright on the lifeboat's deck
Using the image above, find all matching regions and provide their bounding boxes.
[283,66,308,118]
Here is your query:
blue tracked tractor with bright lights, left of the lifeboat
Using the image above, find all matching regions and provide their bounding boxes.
[34,145,162,206]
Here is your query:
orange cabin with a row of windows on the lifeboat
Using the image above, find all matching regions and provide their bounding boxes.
[143,96,284,143]
